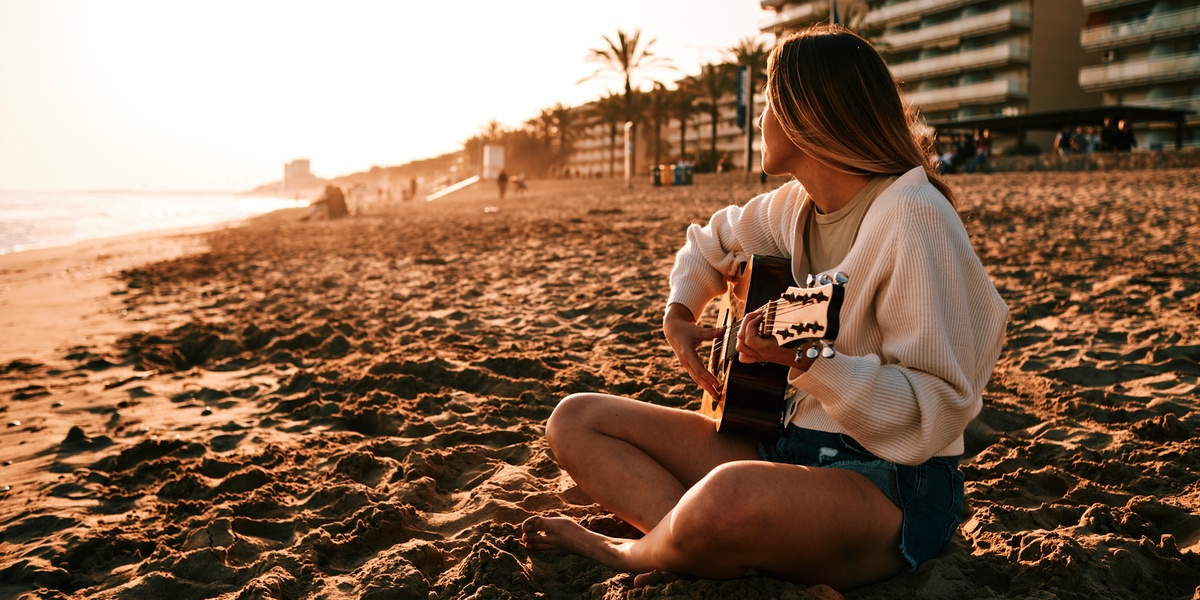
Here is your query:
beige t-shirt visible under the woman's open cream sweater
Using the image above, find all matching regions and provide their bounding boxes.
[796,175,896,276]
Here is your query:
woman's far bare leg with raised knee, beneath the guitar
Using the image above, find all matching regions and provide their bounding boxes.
[546,394,757,532]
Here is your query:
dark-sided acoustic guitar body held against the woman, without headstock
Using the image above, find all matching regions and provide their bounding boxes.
[700,256,794,440]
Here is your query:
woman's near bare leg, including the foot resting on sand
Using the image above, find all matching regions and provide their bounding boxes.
[523,446,906,589]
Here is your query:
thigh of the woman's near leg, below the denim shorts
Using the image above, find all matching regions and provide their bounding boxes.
[672,461,907,589]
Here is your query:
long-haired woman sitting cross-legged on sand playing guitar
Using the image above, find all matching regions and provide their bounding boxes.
[523,26,1008,589]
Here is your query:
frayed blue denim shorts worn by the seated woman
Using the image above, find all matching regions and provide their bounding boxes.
[758,425,964,570]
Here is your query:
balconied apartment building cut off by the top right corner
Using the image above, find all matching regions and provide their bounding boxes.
[1079,0,1200,148]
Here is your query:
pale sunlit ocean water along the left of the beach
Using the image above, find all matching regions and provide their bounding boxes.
[0,191,300,254]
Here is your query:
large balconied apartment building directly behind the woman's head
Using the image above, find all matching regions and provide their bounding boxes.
[761,0,1111,148]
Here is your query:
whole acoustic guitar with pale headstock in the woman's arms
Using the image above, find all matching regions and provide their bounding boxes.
[700,256,847,440]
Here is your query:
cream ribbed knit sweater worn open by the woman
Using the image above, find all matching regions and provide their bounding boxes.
[667,168,1008,464]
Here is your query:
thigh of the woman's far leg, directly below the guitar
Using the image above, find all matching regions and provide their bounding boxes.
[546,394,758,487]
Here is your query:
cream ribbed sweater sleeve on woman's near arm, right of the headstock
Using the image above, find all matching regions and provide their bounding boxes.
[792,173,1008,464]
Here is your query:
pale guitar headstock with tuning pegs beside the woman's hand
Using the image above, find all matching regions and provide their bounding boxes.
[760,272,850,358]
